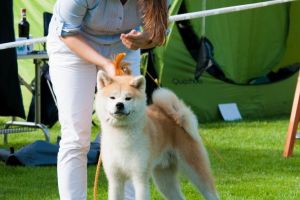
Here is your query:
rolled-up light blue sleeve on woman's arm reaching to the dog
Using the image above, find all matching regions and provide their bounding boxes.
[56,0,88,36]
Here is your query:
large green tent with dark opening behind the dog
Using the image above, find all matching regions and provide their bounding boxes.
[154,0,300,122]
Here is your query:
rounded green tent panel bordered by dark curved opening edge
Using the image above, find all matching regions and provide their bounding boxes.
[206,0,289,83]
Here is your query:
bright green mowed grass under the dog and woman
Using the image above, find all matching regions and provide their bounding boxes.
[0,117,300,200]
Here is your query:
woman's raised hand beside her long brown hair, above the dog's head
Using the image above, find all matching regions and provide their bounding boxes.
[120,30,157,50]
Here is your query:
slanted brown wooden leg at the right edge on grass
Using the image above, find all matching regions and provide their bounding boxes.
[283,73,300,157]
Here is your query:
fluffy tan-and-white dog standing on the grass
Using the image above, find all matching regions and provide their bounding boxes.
[95,71,219,200]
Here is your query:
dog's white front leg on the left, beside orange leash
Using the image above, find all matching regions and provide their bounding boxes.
[108,178,125,200]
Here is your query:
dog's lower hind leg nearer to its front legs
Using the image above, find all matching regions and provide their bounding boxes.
[153,164,184,200]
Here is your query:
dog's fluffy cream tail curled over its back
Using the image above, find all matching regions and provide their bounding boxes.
[152,88,201,142]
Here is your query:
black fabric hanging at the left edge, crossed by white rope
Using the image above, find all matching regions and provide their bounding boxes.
[0,0,25,118]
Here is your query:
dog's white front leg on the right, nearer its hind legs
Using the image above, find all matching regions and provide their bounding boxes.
[132,176,150,200]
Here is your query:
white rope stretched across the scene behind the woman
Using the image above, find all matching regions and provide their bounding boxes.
[0,0,297,50]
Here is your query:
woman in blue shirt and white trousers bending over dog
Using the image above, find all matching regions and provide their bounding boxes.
[47,0,168,200]
